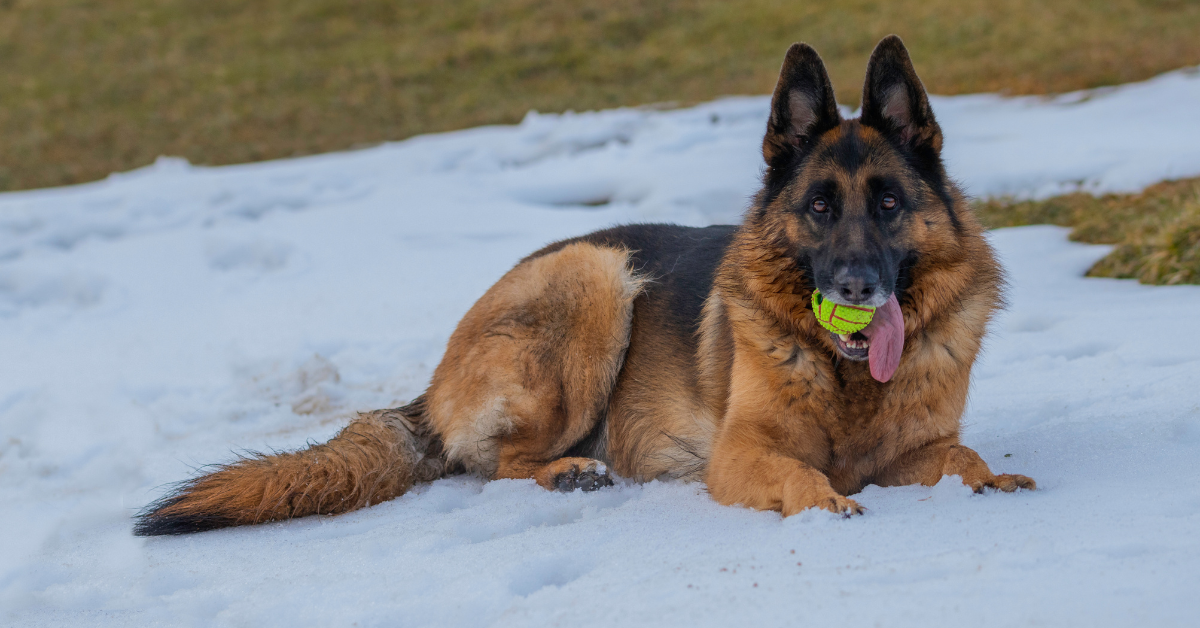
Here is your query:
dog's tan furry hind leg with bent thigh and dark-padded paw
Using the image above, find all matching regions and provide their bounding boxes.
[426,243,643,490]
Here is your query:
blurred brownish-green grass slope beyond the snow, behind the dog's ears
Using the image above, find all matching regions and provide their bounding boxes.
[0,0,1200,190]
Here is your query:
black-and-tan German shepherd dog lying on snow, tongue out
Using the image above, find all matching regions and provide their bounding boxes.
[134,36,1034,536]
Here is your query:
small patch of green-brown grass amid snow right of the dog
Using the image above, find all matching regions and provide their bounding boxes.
[976,178,1200,285]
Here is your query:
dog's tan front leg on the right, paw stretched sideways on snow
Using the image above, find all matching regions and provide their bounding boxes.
[875,436,1037,492]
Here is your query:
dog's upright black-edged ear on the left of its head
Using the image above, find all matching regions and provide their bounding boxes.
[762,43,841,166]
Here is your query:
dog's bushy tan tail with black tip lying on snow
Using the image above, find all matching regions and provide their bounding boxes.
[133,397,444,537]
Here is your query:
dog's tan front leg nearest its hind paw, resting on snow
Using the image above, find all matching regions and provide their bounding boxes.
[708,425,863,516]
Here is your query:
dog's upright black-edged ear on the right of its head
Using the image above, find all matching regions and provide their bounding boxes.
[863,35,942,152]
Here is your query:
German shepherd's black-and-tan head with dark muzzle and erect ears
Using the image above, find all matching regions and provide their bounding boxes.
[750,36,961,360]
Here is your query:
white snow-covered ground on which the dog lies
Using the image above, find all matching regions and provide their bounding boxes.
[0,71,1200,627]
